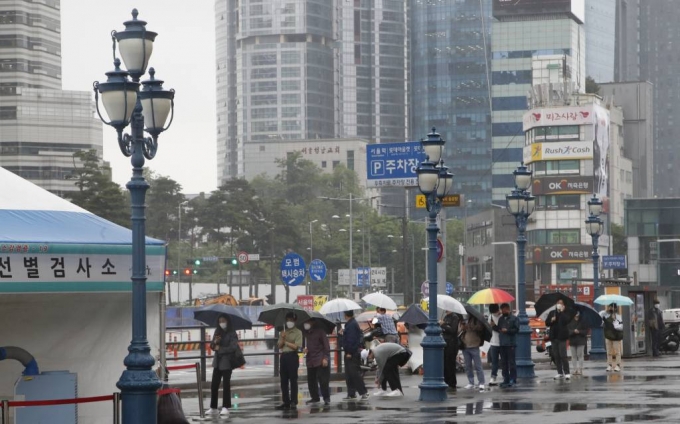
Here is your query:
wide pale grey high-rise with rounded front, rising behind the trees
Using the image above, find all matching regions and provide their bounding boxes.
[215,0,408,184]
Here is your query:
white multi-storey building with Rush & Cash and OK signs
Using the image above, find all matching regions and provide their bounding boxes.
[523,95,633,291]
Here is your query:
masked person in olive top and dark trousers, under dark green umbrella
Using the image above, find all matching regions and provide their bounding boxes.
[276,312,302,411]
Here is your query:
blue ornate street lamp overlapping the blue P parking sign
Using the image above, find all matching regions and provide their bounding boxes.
[416,128,453,402]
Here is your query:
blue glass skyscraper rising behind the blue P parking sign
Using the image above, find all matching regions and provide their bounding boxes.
[409,0,492,217]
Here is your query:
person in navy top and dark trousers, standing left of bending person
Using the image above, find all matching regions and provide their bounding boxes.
[340,311,368,401]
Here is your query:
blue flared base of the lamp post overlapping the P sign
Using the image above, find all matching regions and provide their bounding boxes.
[418,330,449,402]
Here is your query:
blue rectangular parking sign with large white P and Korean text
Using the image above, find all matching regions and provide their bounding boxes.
[366,141,425,187]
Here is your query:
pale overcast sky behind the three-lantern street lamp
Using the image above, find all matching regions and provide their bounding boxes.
[61,0,217,193]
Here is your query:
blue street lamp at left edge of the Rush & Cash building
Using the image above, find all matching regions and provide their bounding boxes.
[505,163,536,378]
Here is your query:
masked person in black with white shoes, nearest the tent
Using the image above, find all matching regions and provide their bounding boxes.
[207,315,241,416]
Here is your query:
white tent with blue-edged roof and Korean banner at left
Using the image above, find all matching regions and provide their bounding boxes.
[0,168,165,423]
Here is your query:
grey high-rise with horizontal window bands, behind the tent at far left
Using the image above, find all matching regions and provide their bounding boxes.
[0,0,103,194]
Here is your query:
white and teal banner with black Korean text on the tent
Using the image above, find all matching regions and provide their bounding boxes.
[0,243,165,293]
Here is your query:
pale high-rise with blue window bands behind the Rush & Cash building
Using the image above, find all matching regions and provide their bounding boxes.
[491,0,586,204]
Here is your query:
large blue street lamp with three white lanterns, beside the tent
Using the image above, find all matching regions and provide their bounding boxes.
[94,9,175,424]
